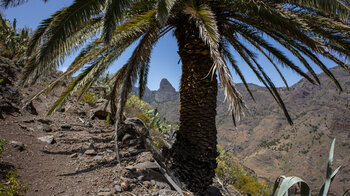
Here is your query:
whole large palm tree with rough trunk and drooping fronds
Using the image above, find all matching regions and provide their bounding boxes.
[15,0,350,195]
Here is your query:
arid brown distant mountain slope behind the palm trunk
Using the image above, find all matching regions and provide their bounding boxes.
[139,67,350,195]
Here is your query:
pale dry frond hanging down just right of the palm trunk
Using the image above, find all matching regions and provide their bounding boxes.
[185,1,247,121]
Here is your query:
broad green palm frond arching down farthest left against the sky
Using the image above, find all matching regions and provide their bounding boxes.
[24,0,105,81]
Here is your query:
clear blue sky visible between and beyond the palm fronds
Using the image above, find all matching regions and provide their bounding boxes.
[2,0,335,90]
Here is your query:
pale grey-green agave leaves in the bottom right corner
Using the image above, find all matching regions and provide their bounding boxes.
[271,139,346,196]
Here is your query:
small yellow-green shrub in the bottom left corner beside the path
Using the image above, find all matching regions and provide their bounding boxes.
[0,170,29,196]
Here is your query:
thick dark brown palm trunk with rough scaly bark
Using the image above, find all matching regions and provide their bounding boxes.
[172,21,218,195]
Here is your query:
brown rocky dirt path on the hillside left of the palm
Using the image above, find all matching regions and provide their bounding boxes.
[0,80,189,195]
